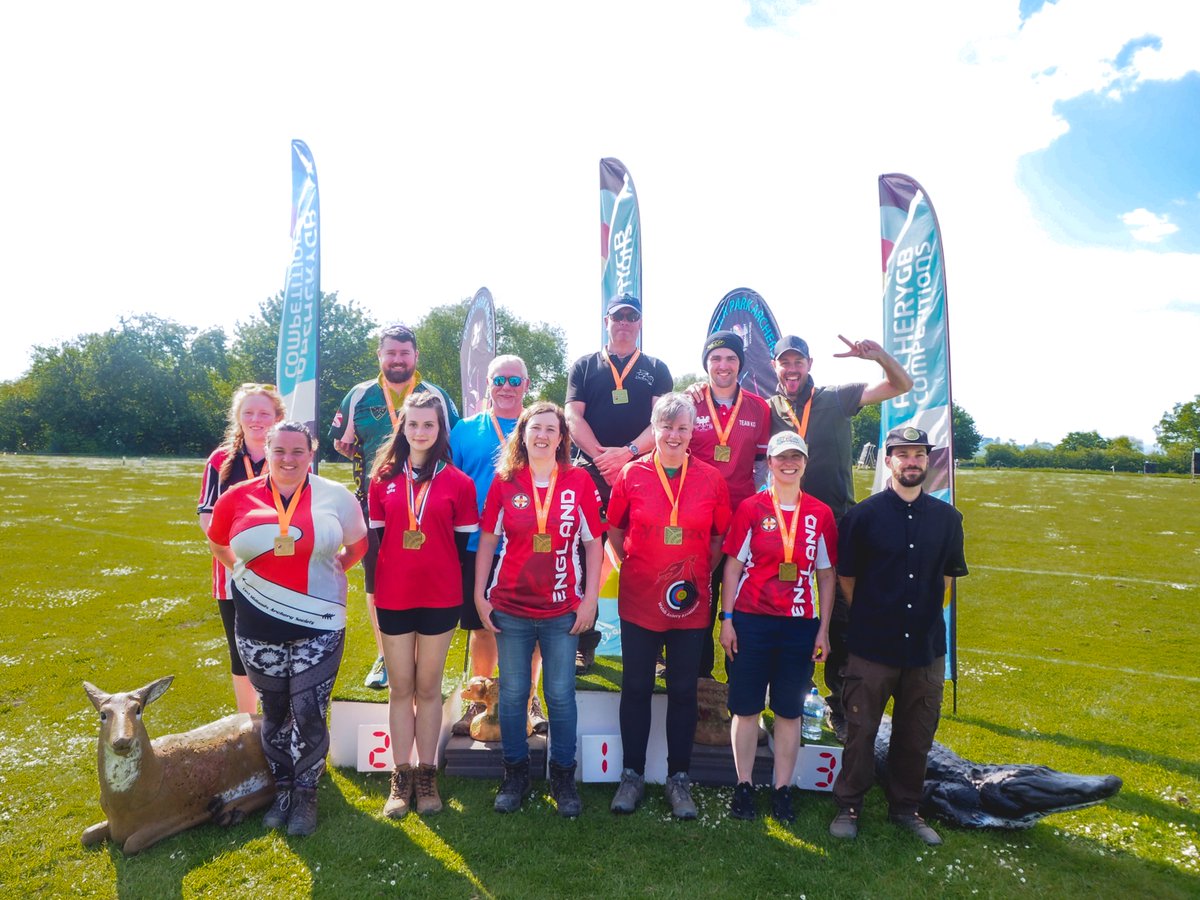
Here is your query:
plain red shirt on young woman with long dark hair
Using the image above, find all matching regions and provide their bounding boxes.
[367,466,479,610]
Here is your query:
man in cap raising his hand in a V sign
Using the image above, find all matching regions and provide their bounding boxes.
[769,335,912,742]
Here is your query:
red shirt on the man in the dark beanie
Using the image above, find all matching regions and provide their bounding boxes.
[688,384,770,509]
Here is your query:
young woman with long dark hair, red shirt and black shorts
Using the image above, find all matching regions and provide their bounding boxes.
[367,391,479,818]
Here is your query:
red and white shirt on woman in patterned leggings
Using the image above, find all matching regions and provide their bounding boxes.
[209,475,367,641]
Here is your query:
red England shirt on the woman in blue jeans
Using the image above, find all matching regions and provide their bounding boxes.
[480,466,607,619]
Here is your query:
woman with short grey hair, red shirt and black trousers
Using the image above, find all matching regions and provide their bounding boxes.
[608,394,730,818]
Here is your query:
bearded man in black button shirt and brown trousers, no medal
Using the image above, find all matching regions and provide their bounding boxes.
[829,425,967,845]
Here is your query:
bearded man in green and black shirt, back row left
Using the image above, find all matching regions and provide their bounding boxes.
[329,325,458,688]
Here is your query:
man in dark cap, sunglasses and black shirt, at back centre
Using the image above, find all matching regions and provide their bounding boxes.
[565,294,674,673]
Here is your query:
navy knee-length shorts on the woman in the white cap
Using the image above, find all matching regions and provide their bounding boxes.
[726,610,821,719]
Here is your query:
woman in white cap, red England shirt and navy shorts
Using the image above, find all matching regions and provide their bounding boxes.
[721,431,838,823]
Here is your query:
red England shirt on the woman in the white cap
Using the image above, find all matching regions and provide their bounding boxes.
[722,492,838,619]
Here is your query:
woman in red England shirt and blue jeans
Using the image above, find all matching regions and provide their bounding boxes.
[475,402,605,817]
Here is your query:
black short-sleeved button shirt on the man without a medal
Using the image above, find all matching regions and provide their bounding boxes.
[838,488,967,668]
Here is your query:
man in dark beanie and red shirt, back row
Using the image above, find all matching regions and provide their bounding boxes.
[688,331,770,678]
